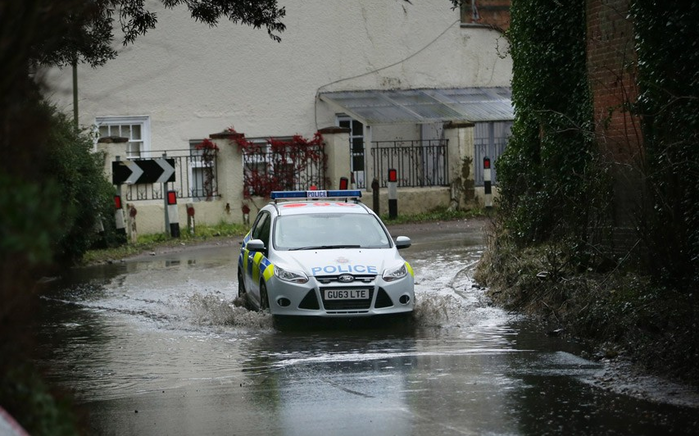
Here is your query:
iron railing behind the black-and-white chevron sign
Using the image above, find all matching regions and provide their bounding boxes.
[122,150,220,202]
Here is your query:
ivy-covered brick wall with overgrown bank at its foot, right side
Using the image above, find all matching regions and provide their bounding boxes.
[476,0,699,386]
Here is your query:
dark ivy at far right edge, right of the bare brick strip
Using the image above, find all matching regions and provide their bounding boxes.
[631,0,699,293]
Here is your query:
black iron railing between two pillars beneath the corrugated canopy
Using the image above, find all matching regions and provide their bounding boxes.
[371,139,449,187]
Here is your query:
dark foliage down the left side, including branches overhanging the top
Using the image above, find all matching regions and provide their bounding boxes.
[0,0,285,435]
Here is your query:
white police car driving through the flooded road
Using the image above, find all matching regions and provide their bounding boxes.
[238,190,415,317]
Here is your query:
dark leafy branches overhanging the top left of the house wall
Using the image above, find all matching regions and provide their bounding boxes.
[0,0,286,72]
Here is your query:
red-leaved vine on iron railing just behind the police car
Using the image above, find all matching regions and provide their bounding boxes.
[228,128,327,198]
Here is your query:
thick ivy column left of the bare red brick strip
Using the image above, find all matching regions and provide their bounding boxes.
[497,0,596,255]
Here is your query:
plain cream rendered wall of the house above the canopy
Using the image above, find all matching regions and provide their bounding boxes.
[50,0,512,150]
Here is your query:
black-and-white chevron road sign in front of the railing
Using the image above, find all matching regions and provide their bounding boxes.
[112,157,175,185]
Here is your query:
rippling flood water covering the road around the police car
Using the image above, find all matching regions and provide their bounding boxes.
[39,226,699,435]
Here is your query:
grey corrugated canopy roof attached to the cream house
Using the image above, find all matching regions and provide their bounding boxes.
[320,87,514,125]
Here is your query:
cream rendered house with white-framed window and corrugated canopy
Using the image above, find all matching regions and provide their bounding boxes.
[49,0,513,235]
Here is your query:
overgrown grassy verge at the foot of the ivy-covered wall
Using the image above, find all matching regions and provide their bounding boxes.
[475,221,699,386]
